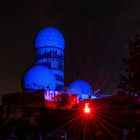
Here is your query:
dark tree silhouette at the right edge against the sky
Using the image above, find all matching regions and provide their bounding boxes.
[117,35,140,94]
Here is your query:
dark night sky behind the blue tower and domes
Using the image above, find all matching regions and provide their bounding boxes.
[0,0,140,103]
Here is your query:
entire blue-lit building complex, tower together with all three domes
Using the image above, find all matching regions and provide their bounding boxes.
[23,27,93,99]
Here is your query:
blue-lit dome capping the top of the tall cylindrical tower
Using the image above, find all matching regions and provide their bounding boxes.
[35,27,65,50]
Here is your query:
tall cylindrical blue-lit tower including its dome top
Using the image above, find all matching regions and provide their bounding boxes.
[35,27,65,91]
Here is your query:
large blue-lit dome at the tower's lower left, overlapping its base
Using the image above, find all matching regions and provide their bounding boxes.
[23,66,56,91]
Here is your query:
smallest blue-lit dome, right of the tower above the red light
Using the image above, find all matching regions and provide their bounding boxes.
[68,80,93,99]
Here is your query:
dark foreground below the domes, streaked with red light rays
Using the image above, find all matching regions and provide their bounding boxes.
[0,96,140,140]
